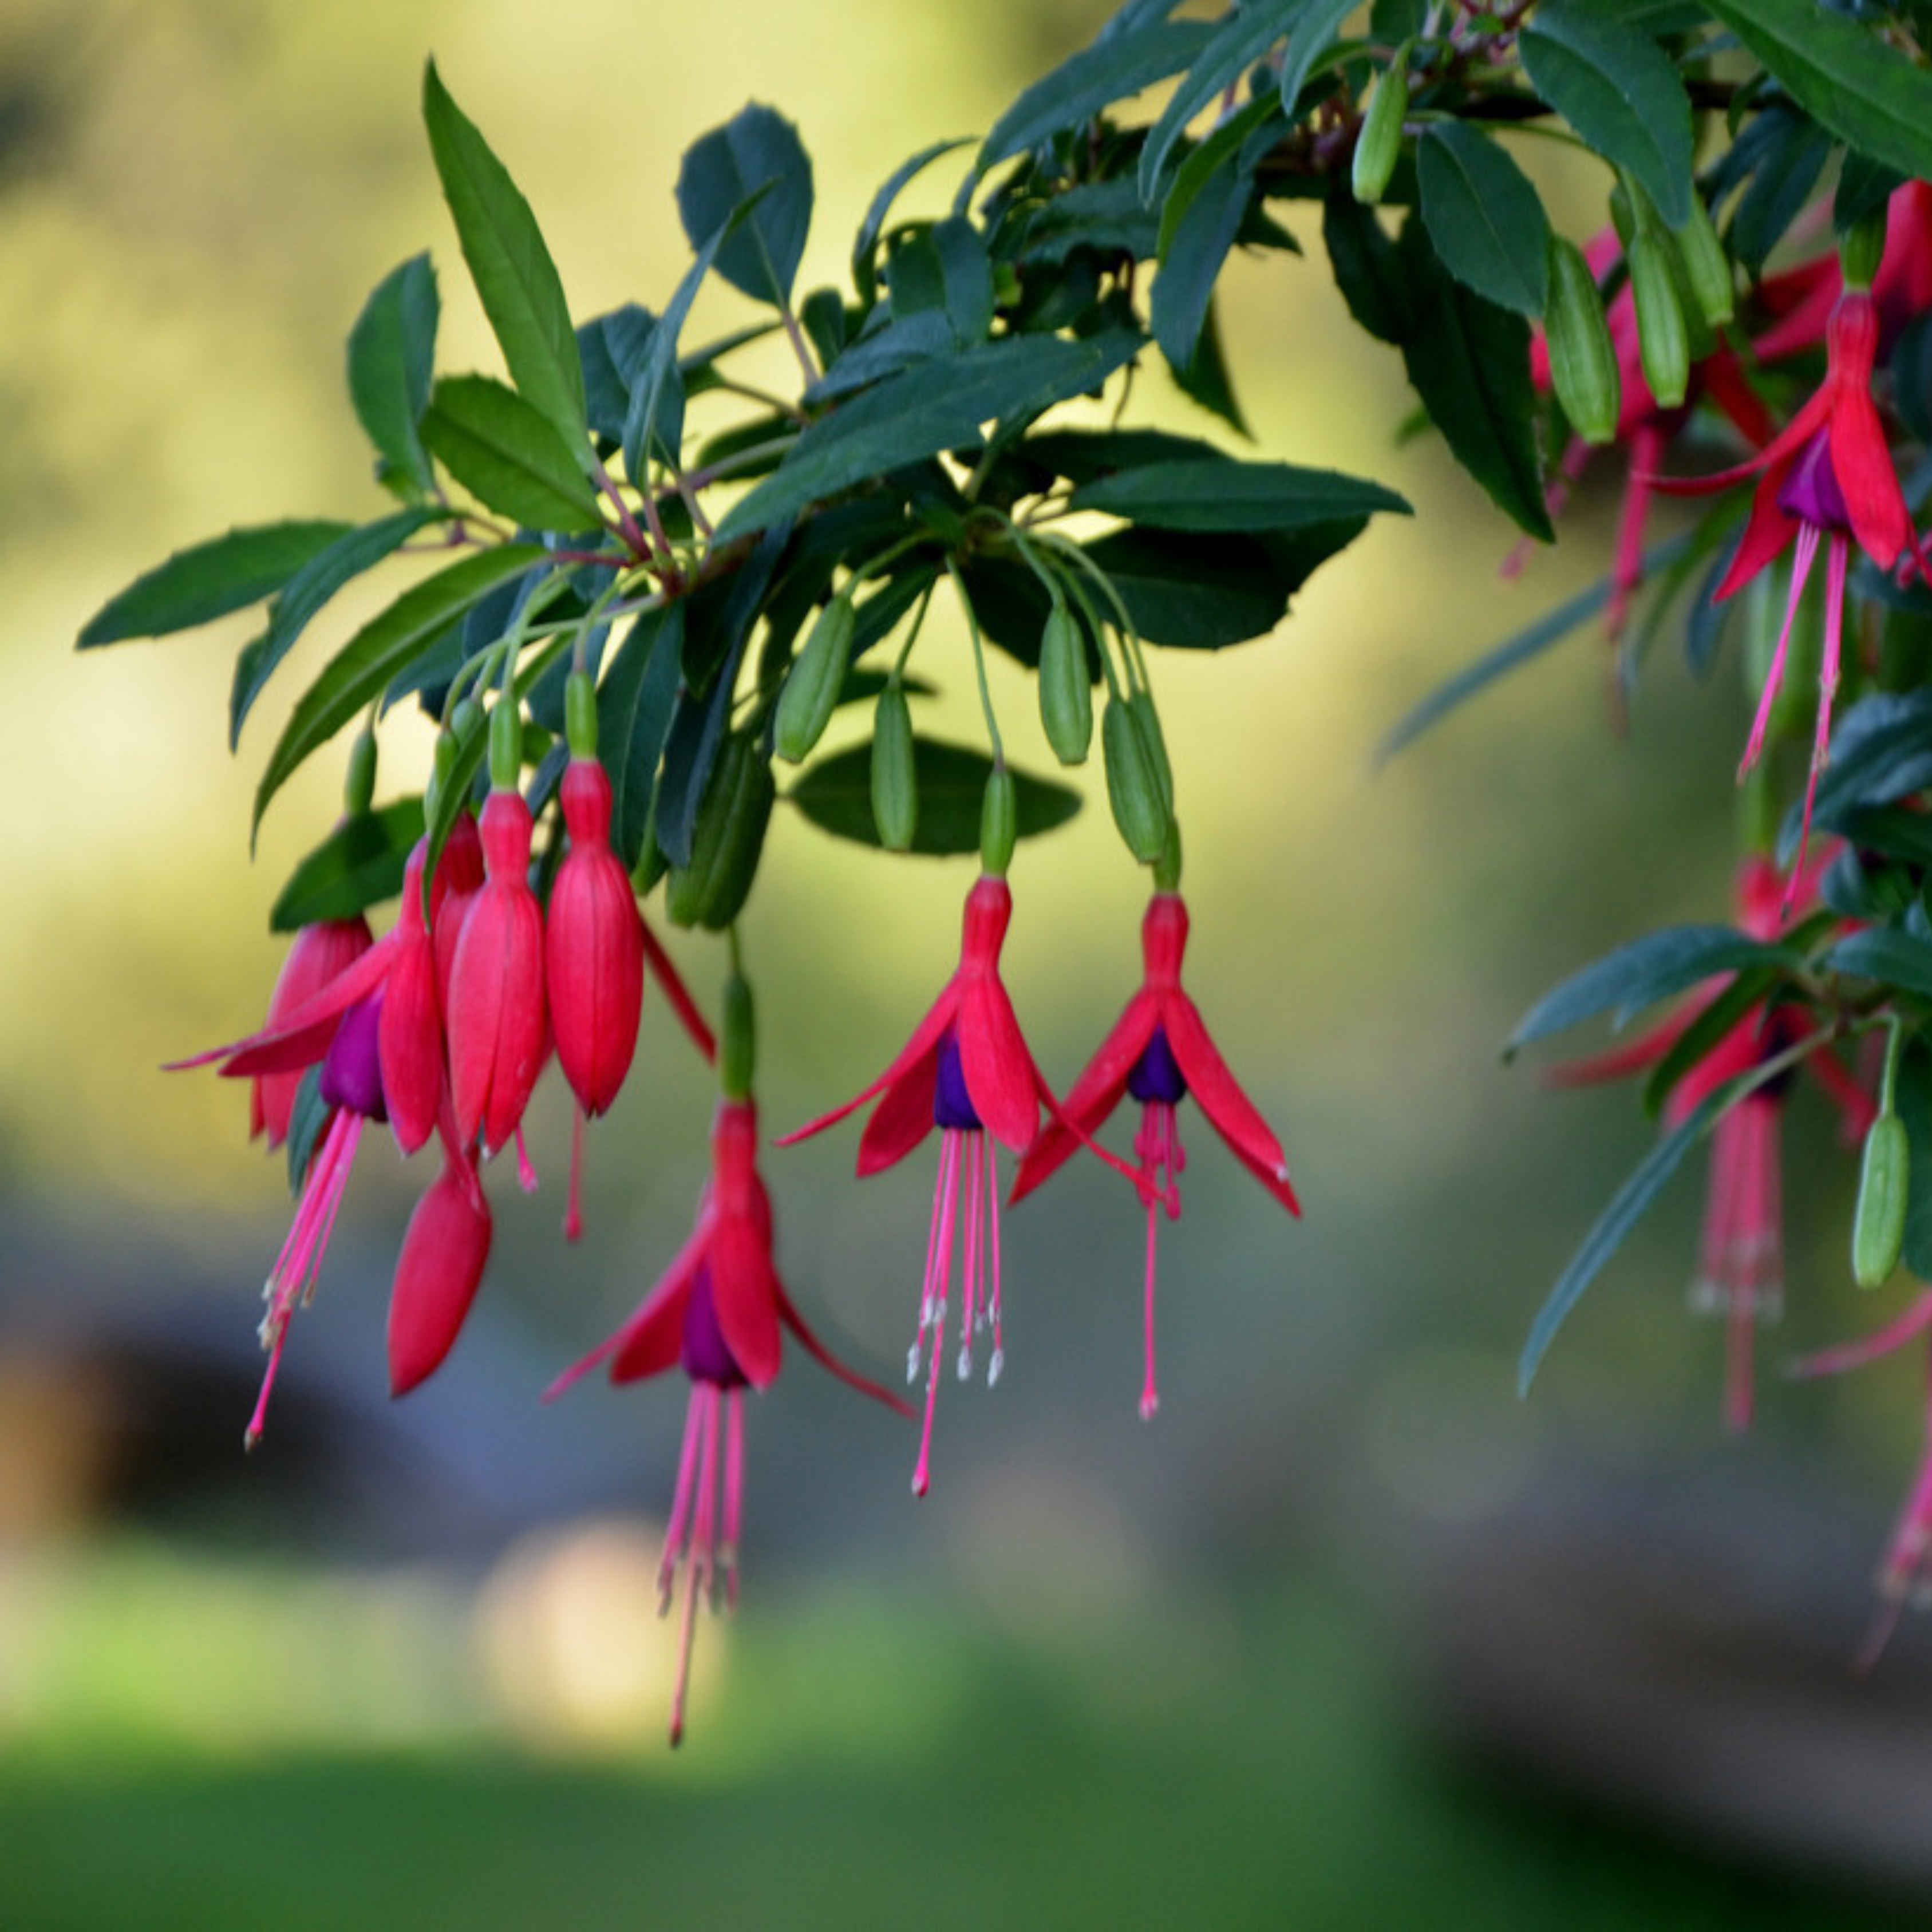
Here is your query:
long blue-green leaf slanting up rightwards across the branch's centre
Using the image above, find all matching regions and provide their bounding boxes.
[717,329,1142,543]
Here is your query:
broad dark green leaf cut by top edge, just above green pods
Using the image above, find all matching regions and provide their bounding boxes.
[1516,0,1693,228]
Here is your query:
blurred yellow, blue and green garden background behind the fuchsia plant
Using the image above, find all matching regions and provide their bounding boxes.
[0,0,1932,1928]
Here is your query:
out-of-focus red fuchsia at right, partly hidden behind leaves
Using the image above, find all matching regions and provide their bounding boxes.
[1551,858,1876,1430]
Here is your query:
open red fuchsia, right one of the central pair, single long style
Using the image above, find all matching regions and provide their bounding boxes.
[1013,892,1302,1418]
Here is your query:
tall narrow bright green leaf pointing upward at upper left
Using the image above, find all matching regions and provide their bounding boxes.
[423,62,589,452]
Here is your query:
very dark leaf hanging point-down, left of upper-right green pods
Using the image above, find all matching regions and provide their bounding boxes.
[1399,216,1555,543]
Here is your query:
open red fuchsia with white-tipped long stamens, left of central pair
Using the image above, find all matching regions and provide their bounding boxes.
[779,874,1089,1495]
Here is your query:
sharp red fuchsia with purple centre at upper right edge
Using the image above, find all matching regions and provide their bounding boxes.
[1658,288,1932,884]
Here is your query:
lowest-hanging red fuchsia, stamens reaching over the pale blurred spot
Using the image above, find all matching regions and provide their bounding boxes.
[543,1099,910,1745]
